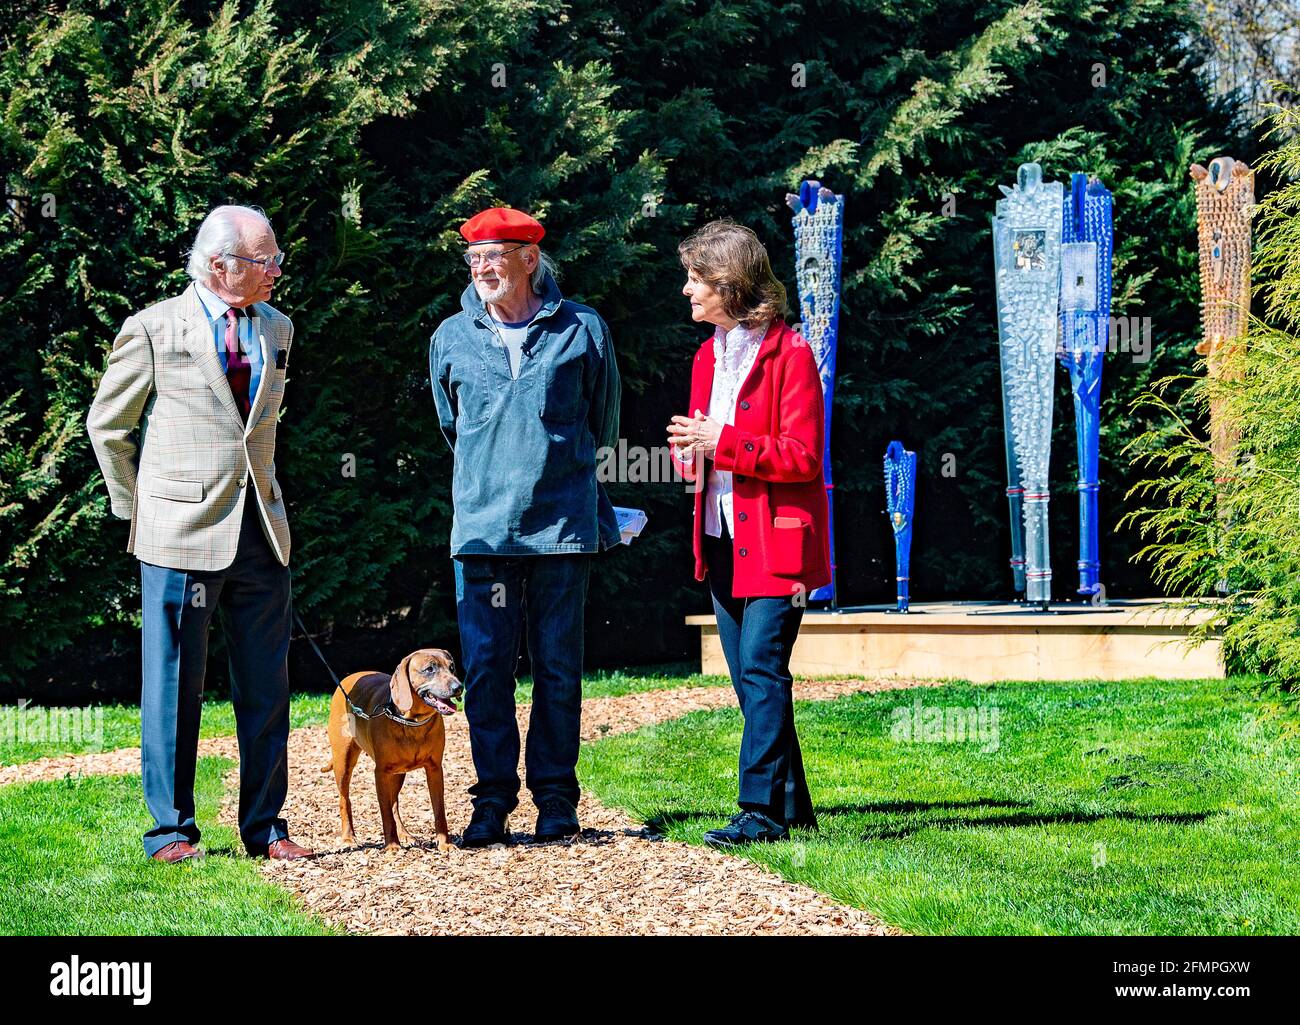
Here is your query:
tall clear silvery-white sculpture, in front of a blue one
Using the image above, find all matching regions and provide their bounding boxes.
[993,164,1063,609]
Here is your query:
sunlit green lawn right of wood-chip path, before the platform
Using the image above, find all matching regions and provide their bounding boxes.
[579,680,1300,934]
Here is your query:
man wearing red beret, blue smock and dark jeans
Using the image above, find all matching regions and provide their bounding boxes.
[429,207,621,847]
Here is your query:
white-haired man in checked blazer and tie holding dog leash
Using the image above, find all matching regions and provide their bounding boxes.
[86,207,311,862]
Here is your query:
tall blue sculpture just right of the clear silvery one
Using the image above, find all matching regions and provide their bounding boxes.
[1060,174,1114,594]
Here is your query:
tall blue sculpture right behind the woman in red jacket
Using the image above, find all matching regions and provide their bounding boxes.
[785,181,844,605]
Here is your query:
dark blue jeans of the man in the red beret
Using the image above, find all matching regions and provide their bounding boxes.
[452,555,590,810]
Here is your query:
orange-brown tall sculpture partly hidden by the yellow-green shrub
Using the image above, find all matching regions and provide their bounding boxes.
[1191,156,1255,475]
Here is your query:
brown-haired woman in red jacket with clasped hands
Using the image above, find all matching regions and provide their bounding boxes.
[668,221,831,847]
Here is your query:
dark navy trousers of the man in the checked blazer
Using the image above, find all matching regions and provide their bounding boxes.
[140,494,291,855]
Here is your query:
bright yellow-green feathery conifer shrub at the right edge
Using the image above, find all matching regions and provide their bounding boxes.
[1128,108,1300,691]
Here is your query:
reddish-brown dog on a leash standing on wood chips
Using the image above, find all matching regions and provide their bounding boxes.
[321,648,465,851]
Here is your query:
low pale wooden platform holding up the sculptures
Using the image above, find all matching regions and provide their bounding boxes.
[686,598,1223,683]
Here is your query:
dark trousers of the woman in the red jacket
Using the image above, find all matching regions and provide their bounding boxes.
[705,524,816,827]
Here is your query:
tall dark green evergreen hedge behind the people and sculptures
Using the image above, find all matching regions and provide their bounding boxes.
[0,0,1252,682]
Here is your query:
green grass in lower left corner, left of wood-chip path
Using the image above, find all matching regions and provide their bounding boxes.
[0,758,330,935]
